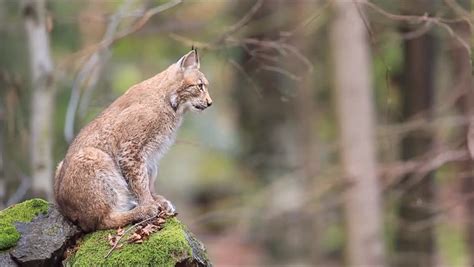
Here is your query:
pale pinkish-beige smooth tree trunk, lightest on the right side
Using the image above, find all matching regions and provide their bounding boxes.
[330,1,384,266]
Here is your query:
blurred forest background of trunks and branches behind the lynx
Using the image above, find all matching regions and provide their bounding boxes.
[0,0,474,266]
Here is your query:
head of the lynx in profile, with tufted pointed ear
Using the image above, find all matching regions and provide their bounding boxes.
[170,49,212,112]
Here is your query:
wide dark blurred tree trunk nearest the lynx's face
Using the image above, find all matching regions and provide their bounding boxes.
[233,0,315,265]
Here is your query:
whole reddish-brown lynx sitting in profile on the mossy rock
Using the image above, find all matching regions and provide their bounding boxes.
[54,49,212,232]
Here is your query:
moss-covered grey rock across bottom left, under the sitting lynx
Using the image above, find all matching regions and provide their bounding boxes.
[0,199,212,267]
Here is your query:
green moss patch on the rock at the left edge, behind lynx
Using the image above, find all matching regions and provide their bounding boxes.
[0,198,49,250]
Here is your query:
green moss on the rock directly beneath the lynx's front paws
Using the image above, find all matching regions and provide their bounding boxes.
[67,218,192,266]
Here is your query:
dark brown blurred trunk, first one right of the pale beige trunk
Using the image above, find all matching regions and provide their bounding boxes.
[396,0,435,267]
